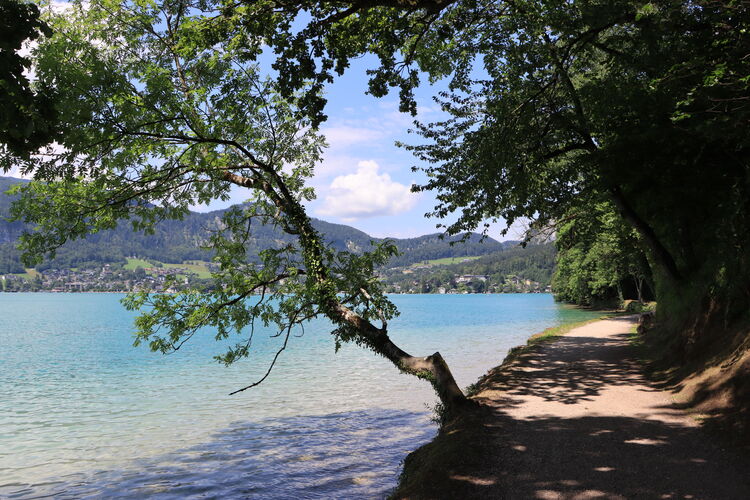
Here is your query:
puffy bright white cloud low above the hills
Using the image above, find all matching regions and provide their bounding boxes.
[317,161,418,222]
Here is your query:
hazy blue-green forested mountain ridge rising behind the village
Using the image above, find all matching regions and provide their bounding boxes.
[0,177,511,274]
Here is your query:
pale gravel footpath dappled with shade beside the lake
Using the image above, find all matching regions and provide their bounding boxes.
[470,317,750,500]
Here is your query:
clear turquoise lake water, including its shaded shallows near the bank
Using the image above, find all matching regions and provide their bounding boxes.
[0,293,596,499]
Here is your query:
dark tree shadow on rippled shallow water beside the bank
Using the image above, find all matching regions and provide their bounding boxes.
[0,409,435,499]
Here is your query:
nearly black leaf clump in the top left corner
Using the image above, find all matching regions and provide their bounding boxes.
[0,0,55,158]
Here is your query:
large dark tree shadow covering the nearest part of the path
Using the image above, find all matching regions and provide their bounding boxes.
[444,415,750,500]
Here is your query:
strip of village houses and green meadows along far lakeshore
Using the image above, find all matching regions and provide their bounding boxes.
[0,245,554,294]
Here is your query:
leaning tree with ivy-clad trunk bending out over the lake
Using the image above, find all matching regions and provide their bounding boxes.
[4,0,467,411]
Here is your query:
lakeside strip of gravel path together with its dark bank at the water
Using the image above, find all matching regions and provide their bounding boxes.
[389,313,750,499]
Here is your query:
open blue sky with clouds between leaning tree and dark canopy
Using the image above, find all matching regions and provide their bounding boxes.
[209,54,519,239]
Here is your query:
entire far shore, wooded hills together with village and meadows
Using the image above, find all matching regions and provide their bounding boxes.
[0,177,556,293]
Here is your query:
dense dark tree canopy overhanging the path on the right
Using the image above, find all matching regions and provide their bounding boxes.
[226,0,750,360]
